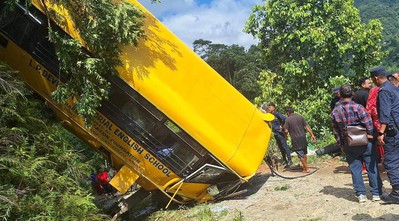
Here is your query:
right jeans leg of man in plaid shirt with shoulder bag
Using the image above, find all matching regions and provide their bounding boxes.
[363,142,382,196]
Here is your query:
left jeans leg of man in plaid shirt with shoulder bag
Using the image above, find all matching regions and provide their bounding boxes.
[344,147,366,196]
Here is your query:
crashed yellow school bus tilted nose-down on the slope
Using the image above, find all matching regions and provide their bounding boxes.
[0,0,271,203]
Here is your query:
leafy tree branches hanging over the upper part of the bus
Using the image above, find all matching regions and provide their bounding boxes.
[3,0,159,120]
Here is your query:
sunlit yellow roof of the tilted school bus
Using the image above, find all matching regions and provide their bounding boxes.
[119,1,264,162]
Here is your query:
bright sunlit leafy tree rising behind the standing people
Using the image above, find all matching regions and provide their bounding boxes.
[246,0,383,142]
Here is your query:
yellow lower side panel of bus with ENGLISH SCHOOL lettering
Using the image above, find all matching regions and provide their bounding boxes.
[0,34,177,190]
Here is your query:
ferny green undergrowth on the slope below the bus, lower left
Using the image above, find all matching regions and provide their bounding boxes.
[0,64,108,220]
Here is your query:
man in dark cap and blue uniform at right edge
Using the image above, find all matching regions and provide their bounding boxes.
[370,67,399,203]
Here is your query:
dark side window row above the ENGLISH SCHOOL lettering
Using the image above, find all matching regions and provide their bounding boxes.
[99,77,206,176]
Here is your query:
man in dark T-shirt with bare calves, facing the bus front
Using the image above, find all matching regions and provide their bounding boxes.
[284,107,316,173]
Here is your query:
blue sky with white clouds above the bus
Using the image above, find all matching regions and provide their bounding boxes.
[138,0,262,48]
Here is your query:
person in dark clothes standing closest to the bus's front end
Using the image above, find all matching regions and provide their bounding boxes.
[262,103,292,168]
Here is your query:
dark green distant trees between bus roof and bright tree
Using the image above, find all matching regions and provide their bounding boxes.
[193,39,262,100]
